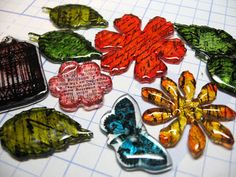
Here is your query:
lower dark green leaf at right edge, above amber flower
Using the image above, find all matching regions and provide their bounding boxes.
[207,57,236,95]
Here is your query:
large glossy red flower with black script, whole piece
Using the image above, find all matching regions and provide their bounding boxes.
[95,14,186,83]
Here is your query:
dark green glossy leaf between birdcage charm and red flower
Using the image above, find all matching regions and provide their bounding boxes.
[29,30,102,63]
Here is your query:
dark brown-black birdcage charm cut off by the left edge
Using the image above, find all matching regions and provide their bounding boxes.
[0,37,48,112]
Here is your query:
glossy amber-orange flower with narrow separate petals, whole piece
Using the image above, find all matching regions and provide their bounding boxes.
[141,71,236,158]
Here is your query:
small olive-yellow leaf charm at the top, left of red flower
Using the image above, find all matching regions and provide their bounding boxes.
[43,4,108,29]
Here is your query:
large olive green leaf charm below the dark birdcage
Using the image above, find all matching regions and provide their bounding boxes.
[0,107,93,161]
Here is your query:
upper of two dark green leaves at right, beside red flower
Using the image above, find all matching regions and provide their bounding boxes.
[175,24,236,61]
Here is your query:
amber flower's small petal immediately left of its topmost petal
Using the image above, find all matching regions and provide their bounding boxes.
[161,76,179,101]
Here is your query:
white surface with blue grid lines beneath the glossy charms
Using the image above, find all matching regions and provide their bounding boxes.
[0,0,236,177]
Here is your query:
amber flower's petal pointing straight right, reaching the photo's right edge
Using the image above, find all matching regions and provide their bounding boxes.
[202,105,236,121]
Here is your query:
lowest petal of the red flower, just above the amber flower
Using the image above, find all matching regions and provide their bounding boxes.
[134,52,167,83]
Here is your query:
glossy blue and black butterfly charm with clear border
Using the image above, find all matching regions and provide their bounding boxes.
[100,94,172,173]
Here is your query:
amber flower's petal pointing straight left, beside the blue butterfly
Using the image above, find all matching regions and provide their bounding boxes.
[142,108,173,125]
